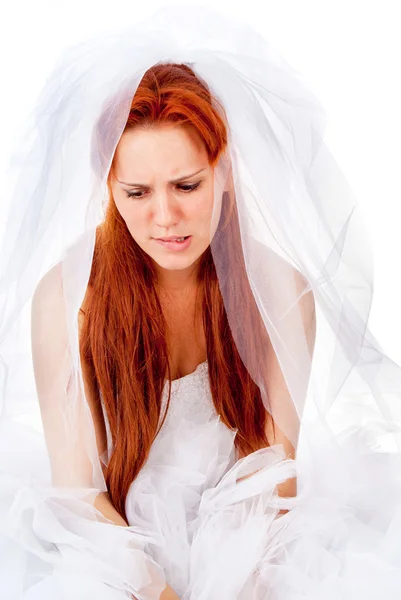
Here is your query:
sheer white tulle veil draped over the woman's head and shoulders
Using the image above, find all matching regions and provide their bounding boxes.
[0,6,401,600]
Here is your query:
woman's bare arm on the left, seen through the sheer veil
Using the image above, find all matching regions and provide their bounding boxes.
[31,263,178,600]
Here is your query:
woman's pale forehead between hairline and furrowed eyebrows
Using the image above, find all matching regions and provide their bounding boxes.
[114,120,208,183]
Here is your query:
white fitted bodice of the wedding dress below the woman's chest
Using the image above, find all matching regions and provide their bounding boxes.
[125,361,236,556]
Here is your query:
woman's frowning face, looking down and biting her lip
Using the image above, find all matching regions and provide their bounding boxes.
[110,125,221,283]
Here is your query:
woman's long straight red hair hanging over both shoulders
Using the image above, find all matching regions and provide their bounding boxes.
[80,63,274,520]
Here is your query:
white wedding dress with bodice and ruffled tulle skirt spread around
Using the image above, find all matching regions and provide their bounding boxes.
[0,362,401,600]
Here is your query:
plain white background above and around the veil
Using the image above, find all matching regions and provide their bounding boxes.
[0,0,401,364]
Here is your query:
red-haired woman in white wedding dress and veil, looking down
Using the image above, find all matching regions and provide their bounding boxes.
[0,5,401,600]
